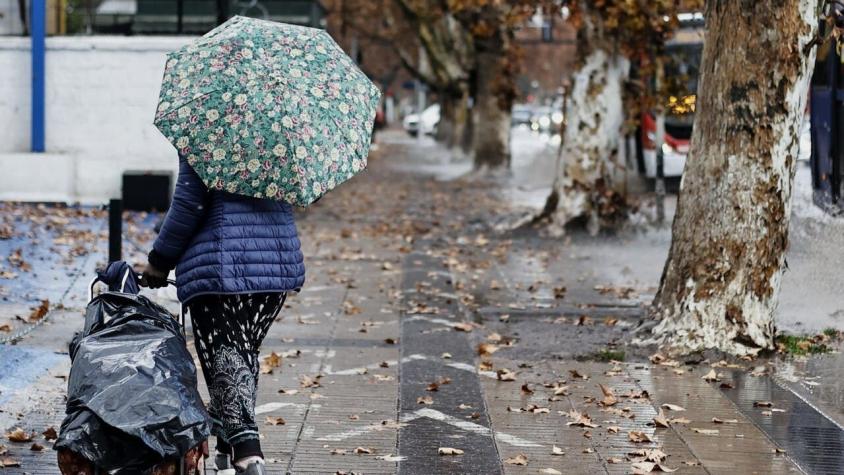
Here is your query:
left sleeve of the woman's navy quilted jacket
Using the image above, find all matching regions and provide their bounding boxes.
[149,158,209,271]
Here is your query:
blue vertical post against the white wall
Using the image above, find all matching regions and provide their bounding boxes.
[29,0,47,152]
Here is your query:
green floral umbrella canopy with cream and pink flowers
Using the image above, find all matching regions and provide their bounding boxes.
[155,16,381,206]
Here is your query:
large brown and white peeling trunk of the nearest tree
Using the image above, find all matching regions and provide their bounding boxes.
[653,0,818,354]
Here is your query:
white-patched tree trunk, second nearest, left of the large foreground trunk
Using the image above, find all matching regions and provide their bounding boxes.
[543,45,629,232]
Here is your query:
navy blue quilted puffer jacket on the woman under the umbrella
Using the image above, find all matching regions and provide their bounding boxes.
[149,159,305,302]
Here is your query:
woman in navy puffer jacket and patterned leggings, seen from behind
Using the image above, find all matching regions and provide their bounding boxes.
[142,157,305,475]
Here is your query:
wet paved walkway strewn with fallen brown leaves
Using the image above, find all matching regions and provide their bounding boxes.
[0,132,844,474]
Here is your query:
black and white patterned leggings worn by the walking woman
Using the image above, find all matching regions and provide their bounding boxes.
[188,293,287,460]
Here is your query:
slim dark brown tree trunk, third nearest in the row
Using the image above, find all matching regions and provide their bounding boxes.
[472,38,512,171]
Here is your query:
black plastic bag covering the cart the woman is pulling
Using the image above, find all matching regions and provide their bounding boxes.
[54,262,211,473]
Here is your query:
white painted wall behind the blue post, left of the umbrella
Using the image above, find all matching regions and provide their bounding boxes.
[0,36,191,203]
